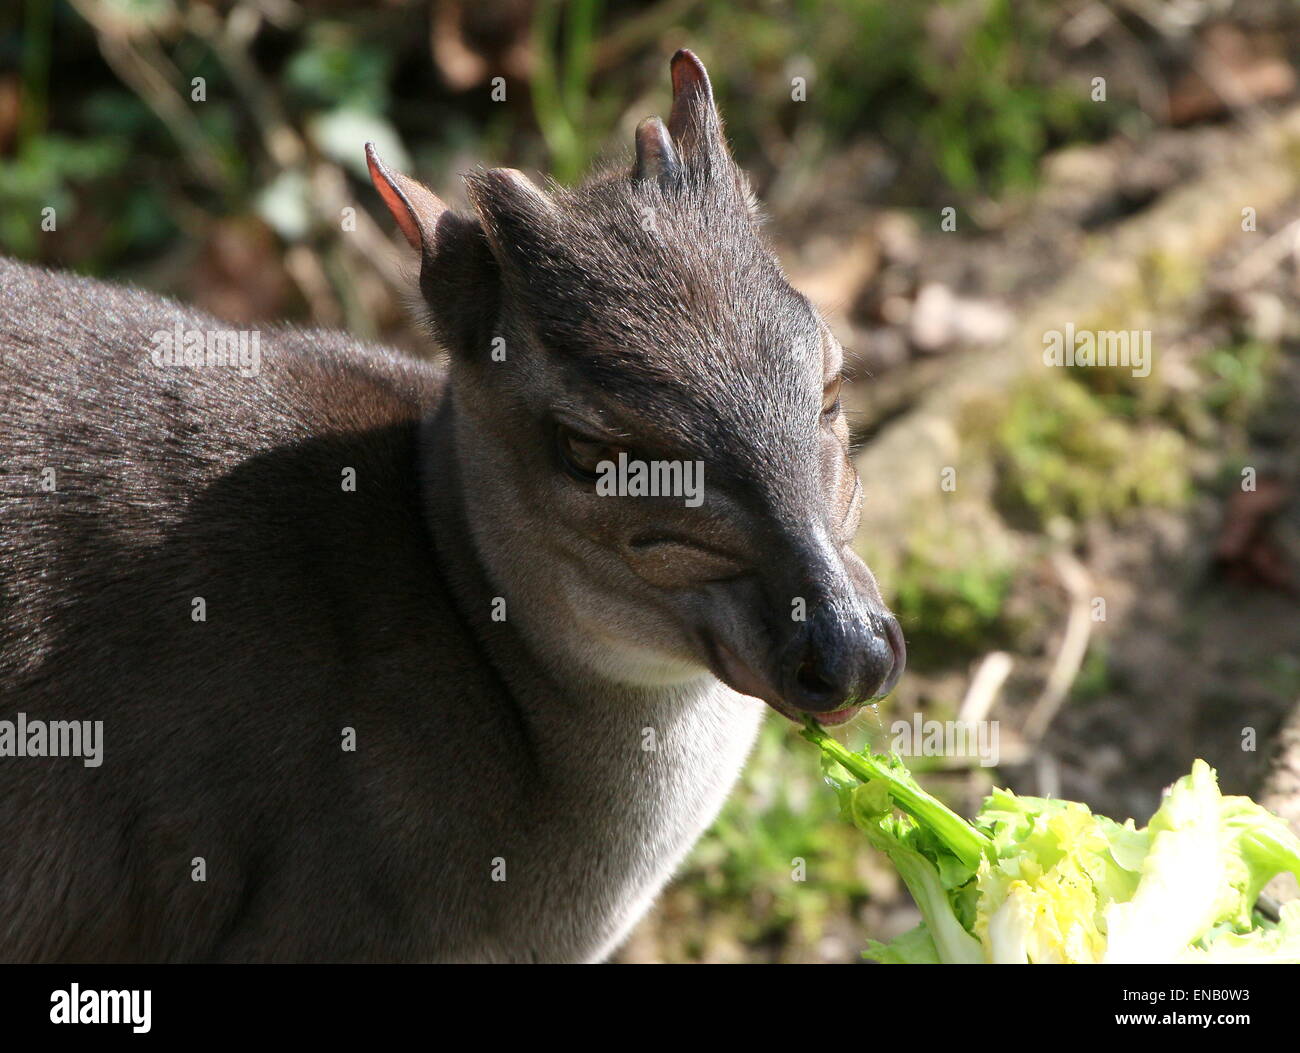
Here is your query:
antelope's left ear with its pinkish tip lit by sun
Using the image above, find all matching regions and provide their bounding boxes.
[365,143,499,350]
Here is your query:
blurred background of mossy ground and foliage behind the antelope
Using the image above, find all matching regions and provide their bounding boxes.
[0,0,1300,961]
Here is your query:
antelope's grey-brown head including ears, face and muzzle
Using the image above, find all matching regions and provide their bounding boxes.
[366,53,904,722]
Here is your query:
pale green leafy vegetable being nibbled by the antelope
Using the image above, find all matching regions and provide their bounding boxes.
[803,722,1300,965]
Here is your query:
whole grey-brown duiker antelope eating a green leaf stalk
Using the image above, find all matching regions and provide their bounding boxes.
[0,51,904,962]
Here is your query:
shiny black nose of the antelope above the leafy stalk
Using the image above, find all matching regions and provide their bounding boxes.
[783,612,907,712]
